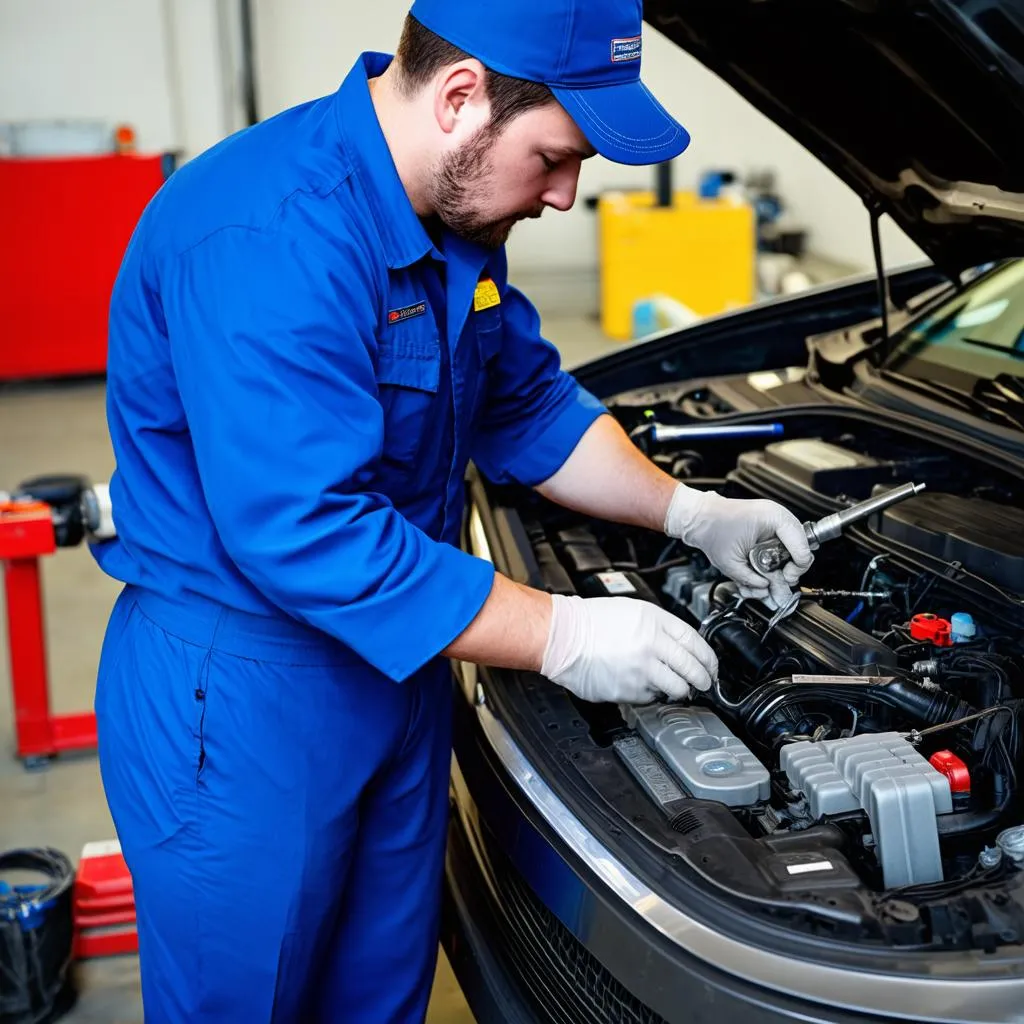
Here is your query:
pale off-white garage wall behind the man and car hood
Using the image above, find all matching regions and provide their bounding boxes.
[0,0,920,280]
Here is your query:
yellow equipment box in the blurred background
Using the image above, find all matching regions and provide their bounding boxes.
[597,191,757,341]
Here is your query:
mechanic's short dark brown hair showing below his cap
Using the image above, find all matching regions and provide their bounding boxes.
[395,14,554,135]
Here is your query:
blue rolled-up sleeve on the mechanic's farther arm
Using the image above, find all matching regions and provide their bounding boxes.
[471,286,605,486]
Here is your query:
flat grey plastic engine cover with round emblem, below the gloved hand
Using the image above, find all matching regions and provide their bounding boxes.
[622,705,771,807]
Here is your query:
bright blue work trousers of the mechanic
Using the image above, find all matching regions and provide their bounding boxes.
[96,587,452,1024]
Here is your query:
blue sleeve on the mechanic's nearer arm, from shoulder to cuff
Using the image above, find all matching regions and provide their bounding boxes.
[161,227,494,680]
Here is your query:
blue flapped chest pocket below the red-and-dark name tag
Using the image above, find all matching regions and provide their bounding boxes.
[377,321,441,466]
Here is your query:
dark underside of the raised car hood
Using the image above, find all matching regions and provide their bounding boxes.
[644,0,1024,273]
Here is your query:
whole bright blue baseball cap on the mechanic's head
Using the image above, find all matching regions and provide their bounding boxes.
[410,0,690,164]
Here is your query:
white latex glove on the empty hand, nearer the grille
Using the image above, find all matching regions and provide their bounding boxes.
[541,594,718,703]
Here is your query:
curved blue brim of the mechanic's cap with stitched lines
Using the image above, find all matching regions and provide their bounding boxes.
[551,81,690,164]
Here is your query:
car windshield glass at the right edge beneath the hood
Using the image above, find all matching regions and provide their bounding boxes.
[885,260,1024,394]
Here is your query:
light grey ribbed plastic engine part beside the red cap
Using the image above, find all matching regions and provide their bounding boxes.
[779,732,953,889]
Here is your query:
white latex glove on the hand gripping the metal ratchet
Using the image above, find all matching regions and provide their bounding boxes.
[665,483,814,609]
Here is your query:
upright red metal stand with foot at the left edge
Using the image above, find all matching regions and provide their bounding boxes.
[0,502,96,761]
